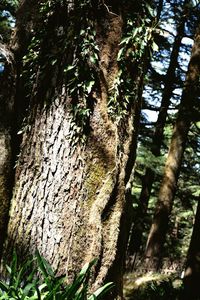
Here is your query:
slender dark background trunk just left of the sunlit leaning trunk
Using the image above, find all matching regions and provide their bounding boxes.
[128,9,186,269]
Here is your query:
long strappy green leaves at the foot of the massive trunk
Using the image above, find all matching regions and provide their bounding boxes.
[0,251,113,300]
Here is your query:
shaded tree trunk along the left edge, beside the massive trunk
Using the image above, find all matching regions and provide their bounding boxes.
[0,1,42,257]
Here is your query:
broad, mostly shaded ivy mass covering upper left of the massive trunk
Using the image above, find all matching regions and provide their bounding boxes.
[22,0,99,144]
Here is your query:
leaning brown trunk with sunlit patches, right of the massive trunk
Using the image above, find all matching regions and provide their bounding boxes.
[145,24,200,268]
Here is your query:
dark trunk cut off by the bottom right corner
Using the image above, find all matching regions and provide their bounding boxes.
[180,202,200,300]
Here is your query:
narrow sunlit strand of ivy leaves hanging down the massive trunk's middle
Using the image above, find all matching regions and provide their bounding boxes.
[64,20,99,144]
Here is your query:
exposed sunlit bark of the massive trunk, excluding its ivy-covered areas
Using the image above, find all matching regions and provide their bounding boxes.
[1,2,145,299]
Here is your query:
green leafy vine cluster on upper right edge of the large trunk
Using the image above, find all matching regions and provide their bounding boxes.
[109,3,158,120]
